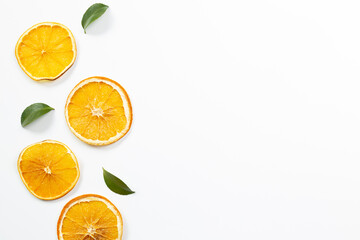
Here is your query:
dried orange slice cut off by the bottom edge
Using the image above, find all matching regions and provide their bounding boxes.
[57,194,123,240]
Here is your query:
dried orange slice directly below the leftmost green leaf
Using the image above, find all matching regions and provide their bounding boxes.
[18,140,80,200]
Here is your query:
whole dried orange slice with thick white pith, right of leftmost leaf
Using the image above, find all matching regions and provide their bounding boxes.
[65,77,132,145]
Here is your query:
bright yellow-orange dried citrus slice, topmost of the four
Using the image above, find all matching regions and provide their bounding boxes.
[15,22,76,81]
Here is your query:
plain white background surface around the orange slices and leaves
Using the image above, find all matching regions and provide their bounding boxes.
[0,0,360,240]
